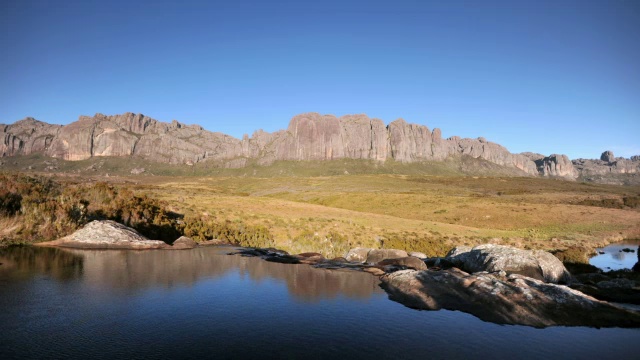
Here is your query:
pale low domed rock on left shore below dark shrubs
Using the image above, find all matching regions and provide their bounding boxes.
[36,220,168,250]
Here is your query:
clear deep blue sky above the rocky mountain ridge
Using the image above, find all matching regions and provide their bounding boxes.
[0,0,640,158]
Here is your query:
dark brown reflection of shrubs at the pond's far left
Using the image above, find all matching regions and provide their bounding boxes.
[0,246,84,281]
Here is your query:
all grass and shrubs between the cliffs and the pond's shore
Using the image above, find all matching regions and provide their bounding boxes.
[0,165,640,257]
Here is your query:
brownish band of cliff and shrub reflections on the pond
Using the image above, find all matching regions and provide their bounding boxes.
[0,247,383,302]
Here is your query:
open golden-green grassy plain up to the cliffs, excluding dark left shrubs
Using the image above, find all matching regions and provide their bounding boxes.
[0,158,640,256]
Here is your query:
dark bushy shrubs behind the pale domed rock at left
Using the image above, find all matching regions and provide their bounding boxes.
[0,175,180,243]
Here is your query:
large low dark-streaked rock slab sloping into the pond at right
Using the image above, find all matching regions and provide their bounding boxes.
[380,268,640,328]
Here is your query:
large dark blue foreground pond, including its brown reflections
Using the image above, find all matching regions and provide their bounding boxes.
[0,248,640,359]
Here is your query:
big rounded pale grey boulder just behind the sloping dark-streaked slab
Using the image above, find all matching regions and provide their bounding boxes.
[446,244,571,283]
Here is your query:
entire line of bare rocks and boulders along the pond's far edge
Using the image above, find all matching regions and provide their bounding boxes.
[33,221,640,327]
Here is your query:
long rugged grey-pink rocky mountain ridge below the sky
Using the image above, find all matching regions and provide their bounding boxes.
[0,113,640,179]
